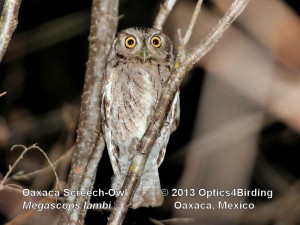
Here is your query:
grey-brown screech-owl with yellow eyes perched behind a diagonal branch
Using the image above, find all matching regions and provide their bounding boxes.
[101,28,180,208]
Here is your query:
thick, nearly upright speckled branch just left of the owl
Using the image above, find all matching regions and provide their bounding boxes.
[59,0,119,225]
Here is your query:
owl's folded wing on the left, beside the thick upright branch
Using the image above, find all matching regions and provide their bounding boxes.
[101,74,121,177]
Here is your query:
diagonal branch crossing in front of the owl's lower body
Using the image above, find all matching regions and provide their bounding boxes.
[108,0,248,225]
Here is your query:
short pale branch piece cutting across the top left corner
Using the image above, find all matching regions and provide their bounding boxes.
[0,0,21,62]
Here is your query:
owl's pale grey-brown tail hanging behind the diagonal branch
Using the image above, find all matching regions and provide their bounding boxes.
[112,162,164,209]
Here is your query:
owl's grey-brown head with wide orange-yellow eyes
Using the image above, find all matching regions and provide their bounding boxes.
[112,27,173,63]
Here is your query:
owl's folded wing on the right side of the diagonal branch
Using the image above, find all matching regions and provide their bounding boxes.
[155,91,180,166]
